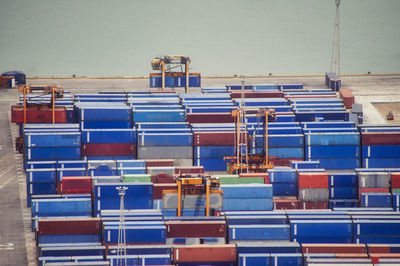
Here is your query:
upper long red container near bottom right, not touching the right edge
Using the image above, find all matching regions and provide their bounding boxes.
[301,244,367,254]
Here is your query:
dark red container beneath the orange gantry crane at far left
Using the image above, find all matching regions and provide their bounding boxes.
[11,105,67,123]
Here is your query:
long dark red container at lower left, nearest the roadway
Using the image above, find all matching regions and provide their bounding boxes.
[38,217,102,235]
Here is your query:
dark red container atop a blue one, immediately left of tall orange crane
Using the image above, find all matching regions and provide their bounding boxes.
[193,131,246,146]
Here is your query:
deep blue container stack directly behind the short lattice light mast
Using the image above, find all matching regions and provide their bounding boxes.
[93,181,153,215]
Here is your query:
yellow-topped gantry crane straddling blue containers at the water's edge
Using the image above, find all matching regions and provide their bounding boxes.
[151,55,190,92]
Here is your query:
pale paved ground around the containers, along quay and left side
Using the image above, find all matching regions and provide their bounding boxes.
[0,76,400,265]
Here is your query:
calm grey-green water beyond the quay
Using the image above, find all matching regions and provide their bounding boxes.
[0,0,400,76]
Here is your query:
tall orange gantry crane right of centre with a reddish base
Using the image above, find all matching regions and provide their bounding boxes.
[224,107,276,174]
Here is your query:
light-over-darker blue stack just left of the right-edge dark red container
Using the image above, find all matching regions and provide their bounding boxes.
[303,122,361,170]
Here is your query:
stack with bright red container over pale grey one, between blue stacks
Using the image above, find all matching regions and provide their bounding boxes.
[298,172,329,209]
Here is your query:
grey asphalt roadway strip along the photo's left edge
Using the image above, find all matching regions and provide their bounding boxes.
[0,89,30,265]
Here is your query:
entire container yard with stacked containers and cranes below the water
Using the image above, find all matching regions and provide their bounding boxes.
[0,74,400,266]
